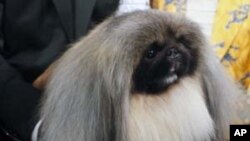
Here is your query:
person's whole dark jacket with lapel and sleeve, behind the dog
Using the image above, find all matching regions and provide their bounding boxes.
[0,0,119,141]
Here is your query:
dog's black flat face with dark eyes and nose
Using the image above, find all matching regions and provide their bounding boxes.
[133,36,198,94]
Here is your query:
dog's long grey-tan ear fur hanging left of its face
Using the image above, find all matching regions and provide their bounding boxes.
[40,37,131,141]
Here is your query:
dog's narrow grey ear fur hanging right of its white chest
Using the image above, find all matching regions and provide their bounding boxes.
[201,46,241,141]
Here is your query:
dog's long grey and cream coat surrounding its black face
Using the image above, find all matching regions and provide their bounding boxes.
[40,10,237,141]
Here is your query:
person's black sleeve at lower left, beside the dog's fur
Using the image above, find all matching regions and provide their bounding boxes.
[0,0,41,141]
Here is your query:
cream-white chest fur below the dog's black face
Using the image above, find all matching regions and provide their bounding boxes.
[128,77,214,141]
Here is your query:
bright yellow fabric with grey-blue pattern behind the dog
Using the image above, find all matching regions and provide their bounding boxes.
[153,0,250,93]
